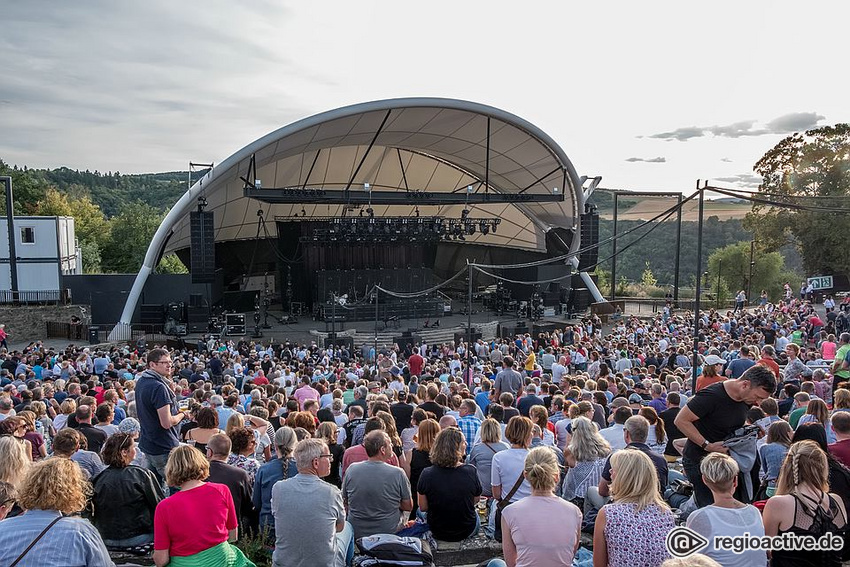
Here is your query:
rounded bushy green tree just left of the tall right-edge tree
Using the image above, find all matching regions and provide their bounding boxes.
[705,242,798,301]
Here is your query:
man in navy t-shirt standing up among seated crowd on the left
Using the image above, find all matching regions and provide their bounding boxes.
[135,348,185,492]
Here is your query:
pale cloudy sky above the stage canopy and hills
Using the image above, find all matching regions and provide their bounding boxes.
[0,0,850,191]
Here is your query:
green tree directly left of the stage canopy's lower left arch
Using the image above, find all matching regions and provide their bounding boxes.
[101,201,164,274]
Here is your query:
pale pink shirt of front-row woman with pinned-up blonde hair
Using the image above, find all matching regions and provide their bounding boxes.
[502,496,581,567]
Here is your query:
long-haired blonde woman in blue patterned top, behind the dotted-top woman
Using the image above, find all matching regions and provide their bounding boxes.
[561,417,611,510]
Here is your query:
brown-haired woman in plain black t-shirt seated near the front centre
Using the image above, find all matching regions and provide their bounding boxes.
[416,426,481,541]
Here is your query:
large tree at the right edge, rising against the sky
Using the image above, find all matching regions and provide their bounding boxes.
[744,124,850,275]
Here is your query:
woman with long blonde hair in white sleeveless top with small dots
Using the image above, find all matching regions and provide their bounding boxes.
[593,449,675,567]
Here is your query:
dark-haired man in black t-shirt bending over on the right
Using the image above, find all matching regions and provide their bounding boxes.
[674,364,776,508]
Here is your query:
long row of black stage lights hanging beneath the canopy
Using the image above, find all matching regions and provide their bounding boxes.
[301,216,501,243]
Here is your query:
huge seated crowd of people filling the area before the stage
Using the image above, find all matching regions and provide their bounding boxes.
[0,292,850,567]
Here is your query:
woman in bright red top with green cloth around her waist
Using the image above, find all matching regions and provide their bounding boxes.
[153,445,254,567]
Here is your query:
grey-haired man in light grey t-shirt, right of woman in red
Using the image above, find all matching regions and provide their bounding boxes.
[272,439,354,567]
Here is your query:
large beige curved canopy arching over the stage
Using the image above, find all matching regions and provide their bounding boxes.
[112,98,595,323]
